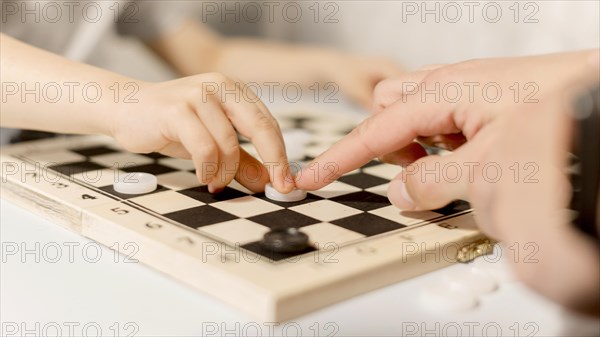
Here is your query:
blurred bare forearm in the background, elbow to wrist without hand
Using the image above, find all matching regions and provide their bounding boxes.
[149,20,336,85]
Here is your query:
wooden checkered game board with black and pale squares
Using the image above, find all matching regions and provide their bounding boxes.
[1,114,490,321]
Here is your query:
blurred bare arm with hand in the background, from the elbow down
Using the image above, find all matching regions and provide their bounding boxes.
[130,11,402,108]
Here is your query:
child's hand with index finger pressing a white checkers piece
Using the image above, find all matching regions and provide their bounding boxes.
[111,73,294,192]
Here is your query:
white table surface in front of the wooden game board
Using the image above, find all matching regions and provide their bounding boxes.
[0,200,600,336]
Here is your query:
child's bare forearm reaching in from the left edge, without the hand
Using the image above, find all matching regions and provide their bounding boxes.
[0,34,138,134]
